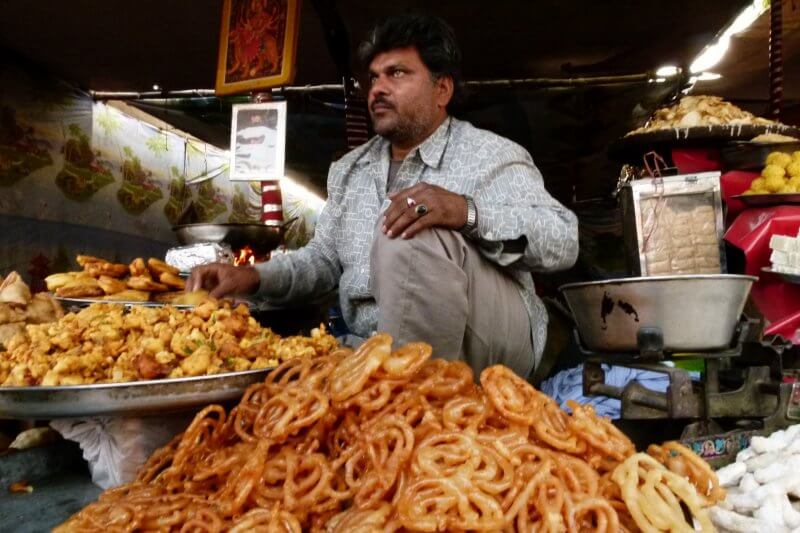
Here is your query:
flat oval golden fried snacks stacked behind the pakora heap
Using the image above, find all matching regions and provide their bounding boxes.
[45,255,193,304]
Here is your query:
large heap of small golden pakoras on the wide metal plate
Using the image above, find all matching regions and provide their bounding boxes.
[0,299,338,386]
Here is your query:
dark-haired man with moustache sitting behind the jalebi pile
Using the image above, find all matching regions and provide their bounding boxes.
[188,15,578,377]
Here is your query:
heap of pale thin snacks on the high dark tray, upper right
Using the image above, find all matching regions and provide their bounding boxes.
[628,95,779,135]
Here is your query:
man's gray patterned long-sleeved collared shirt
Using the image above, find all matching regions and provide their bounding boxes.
[256,118,578,360]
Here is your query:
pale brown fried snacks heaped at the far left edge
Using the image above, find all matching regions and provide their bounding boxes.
[0,272,64,350]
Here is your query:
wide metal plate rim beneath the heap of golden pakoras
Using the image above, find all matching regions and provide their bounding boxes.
[0,369,271,419]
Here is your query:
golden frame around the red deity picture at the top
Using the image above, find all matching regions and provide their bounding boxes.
[215,0,300,95]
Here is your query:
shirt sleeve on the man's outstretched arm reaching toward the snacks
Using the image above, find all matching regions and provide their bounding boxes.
[255,164,342,304]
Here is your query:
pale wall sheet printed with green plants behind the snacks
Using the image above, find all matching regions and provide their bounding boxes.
[0,64,321,281]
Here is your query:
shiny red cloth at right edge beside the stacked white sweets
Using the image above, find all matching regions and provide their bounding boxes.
[725,205,800,338]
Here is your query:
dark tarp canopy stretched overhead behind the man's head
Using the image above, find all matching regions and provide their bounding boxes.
[0,0,752,91]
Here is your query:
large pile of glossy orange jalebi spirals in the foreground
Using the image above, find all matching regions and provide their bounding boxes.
[57,334,719,532]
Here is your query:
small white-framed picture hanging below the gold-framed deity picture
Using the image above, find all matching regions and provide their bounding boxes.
[229,102,286,181]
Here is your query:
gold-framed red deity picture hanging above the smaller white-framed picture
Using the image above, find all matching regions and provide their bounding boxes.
[216,0,300,95]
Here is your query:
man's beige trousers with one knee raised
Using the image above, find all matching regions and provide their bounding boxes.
[370,224,534,380]
